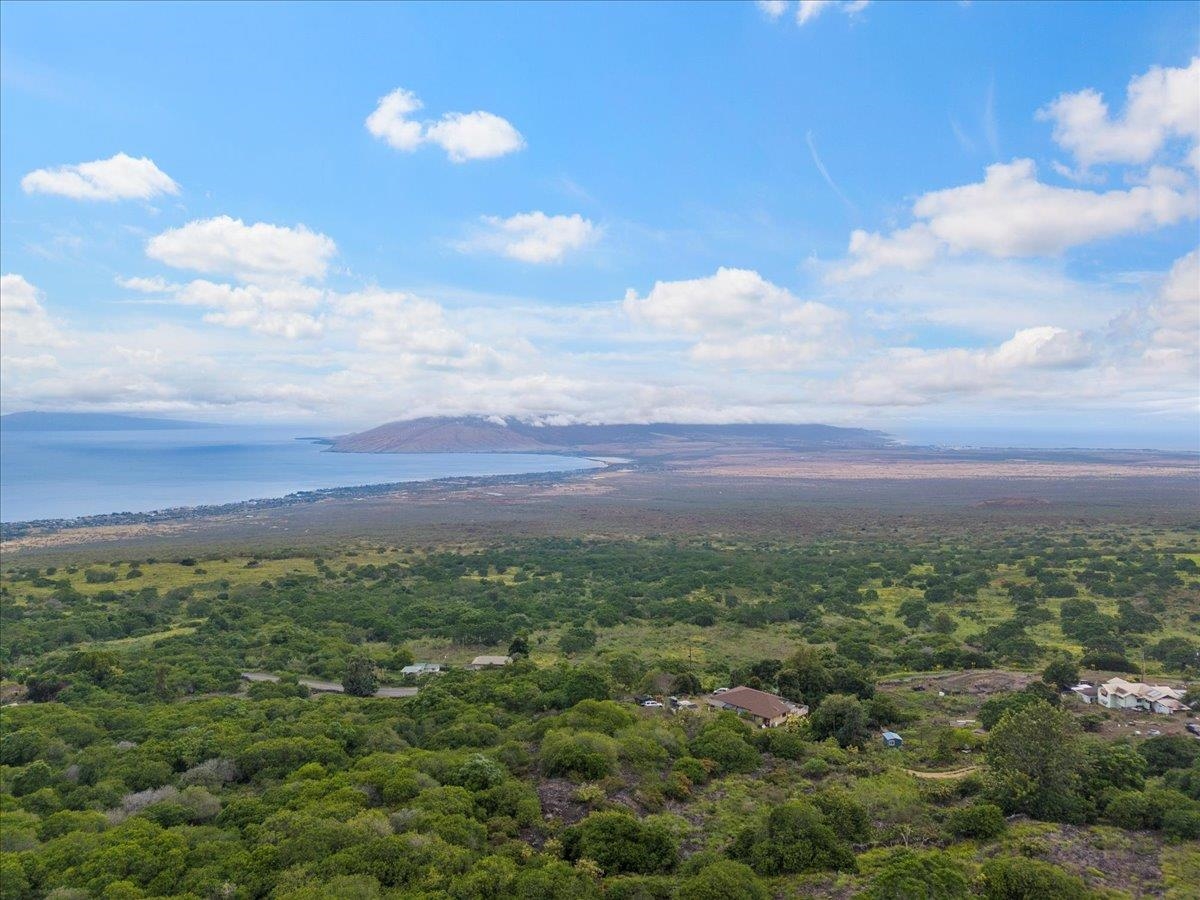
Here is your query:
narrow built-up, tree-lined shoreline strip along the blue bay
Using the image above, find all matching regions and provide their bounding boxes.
[0,454,619,544]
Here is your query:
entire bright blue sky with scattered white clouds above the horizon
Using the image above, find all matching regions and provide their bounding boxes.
[0,2,1200,445]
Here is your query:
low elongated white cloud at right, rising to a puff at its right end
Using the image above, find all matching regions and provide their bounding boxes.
[847,325,1091,406]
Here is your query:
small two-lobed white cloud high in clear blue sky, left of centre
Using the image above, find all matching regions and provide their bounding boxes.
[366,88,524,162]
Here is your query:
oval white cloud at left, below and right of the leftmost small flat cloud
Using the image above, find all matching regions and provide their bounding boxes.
[146,216,337,281]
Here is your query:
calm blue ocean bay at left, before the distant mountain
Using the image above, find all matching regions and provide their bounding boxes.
[0,427,602,522]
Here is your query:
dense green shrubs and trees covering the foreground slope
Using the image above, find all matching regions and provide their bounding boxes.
[0,528,1200,900]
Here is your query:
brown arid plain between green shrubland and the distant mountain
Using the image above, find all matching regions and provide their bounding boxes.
[2,445,1200,557]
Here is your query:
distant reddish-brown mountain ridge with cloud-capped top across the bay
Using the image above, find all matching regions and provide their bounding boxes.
[332,415,894,454]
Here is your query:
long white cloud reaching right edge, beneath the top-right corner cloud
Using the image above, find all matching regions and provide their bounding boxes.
[834,160,1196,278]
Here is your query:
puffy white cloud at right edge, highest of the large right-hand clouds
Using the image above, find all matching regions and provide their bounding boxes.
[1037,58,1200,170]
